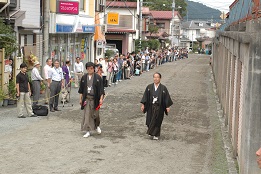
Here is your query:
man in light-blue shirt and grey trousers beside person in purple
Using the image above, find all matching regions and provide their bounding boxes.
[48,60,64,112]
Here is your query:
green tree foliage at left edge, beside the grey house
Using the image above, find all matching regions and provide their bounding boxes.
[0,19,17,57]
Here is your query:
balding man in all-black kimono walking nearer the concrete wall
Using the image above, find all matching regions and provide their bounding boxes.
[141,73,173,140]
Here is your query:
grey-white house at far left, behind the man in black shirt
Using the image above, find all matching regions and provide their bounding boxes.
[0,0,42,61]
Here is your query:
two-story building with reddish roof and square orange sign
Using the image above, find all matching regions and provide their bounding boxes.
[105,1,138,54]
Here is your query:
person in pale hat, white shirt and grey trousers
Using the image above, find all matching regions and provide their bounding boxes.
[31,61,43,105]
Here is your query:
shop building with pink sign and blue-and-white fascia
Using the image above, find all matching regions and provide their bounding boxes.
[49,0,96,63]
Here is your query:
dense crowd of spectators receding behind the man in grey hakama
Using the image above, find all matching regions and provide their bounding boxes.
[90,48,188,87]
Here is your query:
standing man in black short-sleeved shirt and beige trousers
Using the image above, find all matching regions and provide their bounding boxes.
[16,63,36,118]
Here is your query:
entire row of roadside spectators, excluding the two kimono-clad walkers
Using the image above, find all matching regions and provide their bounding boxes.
[16,48,188,118]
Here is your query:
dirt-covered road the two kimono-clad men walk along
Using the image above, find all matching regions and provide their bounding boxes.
[0,55,227,174]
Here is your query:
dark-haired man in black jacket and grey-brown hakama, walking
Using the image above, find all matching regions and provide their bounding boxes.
[78,62,104,138]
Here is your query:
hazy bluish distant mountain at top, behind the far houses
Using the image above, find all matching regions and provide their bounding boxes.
[183,0,221,22]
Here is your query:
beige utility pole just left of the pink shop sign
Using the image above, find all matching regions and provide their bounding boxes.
[42,0,50,65]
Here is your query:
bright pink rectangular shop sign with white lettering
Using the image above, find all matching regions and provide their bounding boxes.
[57,1,79,15]
